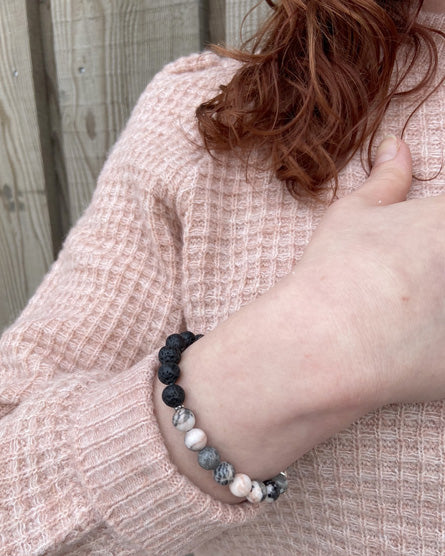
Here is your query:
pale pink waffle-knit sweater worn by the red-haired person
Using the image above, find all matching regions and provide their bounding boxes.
[0,9,445,556]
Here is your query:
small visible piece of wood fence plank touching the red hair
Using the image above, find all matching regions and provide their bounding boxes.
[226,0,271,47]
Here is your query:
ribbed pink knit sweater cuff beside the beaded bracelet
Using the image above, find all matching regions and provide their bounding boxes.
[76,354,261,555]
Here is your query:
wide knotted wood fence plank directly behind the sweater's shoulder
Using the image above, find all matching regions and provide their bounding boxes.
[51,0,202,228]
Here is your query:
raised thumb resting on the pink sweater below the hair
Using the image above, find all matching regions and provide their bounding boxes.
[354,135,412,205]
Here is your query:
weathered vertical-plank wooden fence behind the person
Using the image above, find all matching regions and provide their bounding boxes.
[0,0,270,332]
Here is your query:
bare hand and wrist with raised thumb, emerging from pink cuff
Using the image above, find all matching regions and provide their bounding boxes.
[155,136,445,503]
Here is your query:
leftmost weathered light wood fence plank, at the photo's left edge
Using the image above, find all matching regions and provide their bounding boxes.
[0,0,53,331]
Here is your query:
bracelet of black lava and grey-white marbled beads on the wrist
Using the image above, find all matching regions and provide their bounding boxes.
[158,331,288,503]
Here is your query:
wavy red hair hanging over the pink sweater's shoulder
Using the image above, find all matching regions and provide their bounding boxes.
[196,0,445,198]
